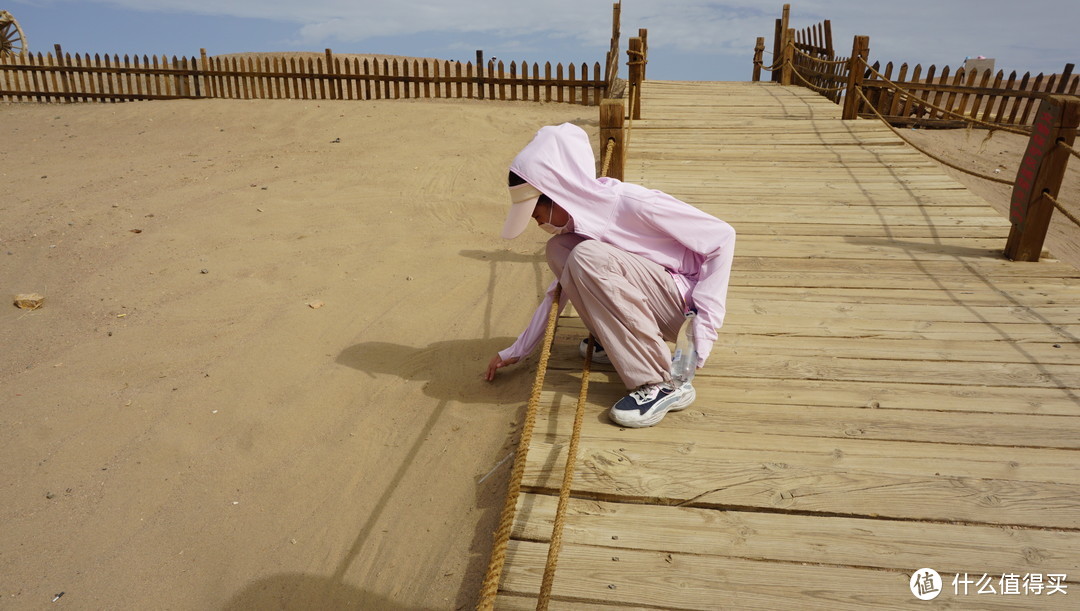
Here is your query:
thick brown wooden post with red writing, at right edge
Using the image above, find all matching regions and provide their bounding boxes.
[1005,95,1080,261]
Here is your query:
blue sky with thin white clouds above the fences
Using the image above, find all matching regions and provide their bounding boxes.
[8,0,1080,81]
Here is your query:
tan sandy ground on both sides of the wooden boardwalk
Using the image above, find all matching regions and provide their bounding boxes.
[0,91,1080,610]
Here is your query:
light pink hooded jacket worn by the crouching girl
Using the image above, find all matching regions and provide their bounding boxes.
[499,123,735,367]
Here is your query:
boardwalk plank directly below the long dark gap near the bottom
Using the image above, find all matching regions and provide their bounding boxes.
[512,494,1080,575]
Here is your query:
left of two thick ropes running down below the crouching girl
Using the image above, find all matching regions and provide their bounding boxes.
[476,286,563,611]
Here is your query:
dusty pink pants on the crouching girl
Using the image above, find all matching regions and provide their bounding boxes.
[548,233,684,389]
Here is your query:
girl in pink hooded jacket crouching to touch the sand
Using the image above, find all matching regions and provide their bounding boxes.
[485,123,735,427]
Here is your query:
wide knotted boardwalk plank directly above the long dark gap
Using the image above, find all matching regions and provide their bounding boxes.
[523,438,1080,529]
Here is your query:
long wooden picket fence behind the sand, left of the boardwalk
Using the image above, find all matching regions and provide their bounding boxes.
[0,42,618,106]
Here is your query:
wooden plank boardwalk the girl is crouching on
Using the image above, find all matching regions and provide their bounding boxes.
[497,82,1080,610]
